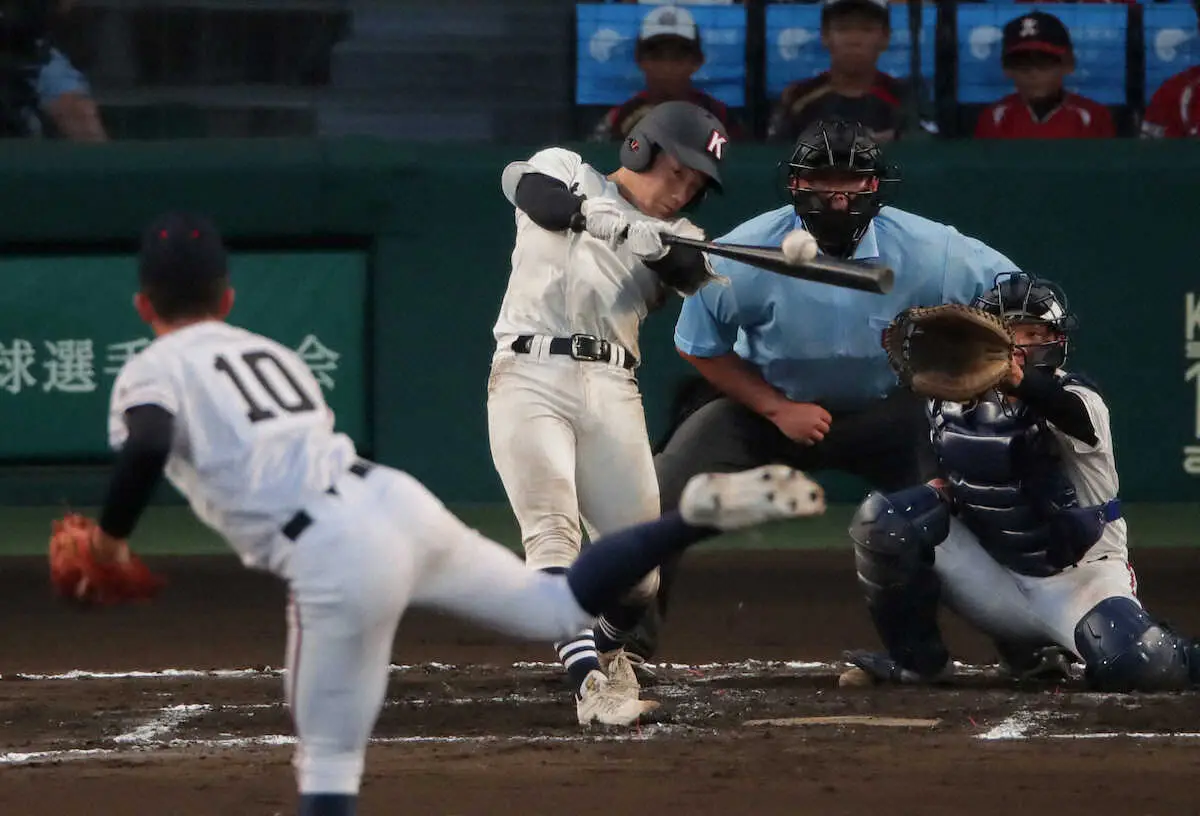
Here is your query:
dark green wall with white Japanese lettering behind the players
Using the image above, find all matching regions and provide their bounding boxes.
[0,139,1200,504]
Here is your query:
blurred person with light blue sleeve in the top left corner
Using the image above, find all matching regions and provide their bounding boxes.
[0,0,108,142]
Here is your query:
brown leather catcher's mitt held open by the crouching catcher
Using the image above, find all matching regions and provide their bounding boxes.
[883,304,1013,402]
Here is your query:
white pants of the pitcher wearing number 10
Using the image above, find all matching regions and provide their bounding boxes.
[280,466,594,794]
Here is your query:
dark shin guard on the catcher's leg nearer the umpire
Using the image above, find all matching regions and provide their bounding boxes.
[850,485,949,676]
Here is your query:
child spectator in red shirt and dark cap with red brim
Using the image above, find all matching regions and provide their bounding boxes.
[976,11,1116,139]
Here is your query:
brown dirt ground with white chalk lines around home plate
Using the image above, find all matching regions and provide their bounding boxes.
[0,550,1200,816]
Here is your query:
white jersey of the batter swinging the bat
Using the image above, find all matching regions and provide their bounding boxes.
[493,148,680,356]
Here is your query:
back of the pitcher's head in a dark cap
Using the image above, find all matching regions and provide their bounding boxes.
[138,212,229,320]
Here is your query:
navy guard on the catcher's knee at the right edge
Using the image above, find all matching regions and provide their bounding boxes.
[1075,596,1200,691]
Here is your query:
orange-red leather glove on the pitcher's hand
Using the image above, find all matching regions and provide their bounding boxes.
[49,512,166,605]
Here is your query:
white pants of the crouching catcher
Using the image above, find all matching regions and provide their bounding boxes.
[934,518,1138,656]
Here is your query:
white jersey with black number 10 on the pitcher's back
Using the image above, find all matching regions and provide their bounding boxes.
[108,322,355,568]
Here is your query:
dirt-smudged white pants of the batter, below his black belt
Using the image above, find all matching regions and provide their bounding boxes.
[487,348,659,602]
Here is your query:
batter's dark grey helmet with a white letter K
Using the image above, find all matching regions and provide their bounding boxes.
[620,101,730,192]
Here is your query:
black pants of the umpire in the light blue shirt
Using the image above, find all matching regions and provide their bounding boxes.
[630,383,936,656]
